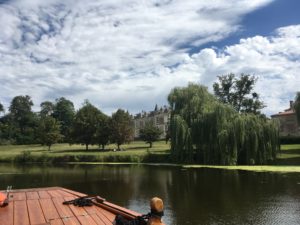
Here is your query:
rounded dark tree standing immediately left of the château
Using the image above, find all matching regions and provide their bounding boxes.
[111,109,133,150]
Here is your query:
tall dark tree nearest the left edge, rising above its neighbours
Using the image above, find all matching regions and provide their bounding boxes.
[9,95,38,144]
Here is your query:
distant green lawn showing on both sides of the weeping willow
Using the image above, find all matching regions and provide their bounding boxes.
[0,141,300,166]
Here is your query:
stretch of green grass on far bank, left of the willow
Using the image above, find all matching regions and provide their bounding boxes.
[0,141,170,162]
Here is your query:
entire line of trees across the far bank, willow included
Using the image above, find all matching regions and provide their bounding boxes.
[0,74,300,165]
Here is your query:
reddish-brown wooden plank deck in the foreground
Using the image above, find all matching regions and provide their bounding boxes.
[0,187,140,225]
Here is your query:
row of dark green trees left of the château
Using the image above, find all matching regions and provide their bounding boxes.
[0,95,133,150]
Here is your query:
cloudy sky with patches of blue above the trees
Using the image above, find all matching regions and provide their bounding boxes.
[0,0,300,115]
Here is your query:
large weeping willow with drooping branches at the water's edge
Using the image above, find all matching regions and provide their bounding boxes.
[169,84,279,165]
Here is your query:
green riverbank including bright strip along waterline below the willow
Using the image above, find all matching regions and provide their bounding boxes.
[0,141,300,168]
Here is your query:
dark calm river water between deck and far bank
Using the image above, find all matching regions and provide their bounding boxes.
[0,164,300,225]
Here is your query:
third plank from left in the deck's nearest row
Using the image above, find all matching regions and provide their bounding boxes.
[27,199,46,225]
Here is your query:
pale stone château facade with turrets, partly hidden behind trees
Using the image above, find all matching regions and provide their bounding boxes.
[133,106,171,139]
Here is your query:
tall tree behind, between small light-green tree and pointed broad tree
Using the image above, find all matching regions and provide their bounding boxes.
[52,97,75,142]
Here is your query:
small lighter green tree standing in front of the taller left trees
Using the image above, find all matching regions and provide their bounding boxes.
[37,116,63,151]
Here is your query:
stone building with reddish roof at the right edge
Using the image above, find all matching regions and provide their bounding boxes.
[271,101,300,136]
